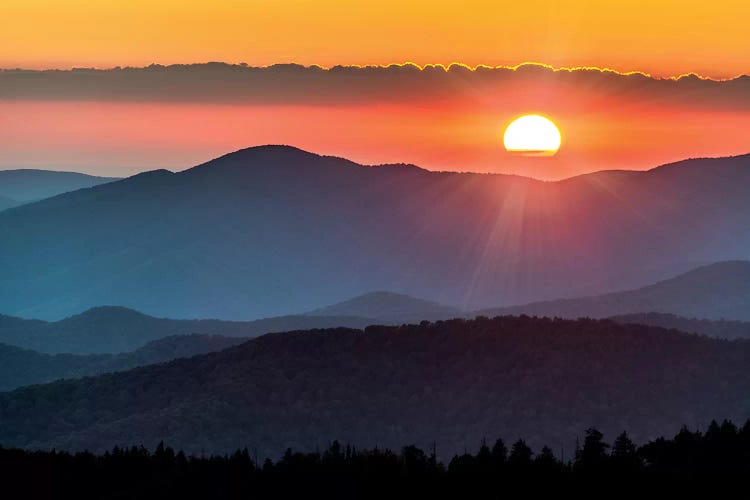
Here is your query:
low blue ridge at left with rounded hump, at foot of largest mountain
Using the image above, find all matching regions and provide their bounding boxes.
[0,306,372,354]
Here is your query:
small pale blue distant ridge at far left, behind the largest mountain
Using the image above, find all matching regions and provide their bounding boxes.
[0,169,117,210]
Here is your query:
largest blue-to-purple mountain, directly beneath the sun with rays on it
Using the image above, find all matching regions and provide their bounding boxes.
[0,146,750,319]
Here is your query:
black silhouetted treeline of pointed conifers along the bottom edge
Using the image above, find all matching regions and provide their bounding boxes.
[0,421,750,498]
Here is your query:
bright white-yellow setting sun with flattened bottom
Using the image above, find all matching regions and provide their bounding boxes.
[503,115,562,156]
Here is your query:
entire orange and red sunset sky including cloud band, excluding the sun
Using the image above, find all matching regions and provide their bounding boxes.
[0,0,750,179]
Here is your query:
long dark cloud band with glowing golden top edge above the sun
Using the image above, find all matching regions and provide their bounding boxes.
[0,63,750,111]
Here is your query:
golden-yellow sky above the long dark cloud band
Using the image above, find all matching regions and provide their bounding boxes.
[0,0,750,78]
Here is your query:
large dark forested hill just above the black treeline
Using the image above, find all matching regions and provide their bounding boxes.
[0,317,750,456]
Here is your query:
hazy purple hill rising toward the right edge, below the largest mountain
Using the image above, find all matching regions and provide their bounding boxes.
[479,261,750,320]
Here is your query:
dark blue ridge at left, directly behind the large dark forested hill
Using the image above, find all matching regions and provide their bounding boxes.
[0,335,246,391]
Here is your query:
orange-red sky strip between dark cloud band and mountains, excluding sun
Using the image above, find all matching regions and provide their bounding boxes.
[0,94,750,179]
